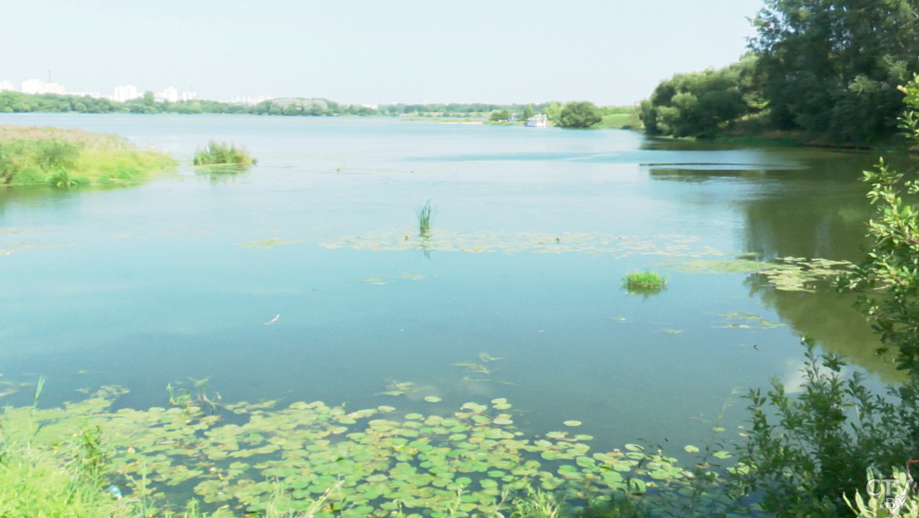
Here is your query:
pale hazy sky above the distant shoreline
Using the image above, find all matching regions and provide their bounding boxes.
[0,0,762,105]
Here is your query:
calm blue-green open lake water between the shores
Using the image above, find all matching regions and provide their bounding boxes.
[0,115,893,464]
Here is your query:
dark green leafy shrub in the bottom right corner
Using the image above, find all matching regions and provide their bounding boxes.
[737,345,919,517]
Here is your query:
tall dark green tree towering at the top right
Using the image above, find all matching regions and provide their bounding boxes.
[750,0,919,141]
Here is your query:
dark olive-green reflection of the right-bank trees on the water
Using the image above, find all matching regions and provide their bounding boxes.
[650,144,919,382]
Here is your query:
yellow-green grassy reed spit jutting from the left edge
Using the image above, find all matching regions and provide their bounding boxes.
[0,125,178,188]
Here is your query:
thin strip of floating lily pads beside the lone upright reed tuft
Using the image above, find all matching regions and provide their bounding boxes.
[320,230,724,258]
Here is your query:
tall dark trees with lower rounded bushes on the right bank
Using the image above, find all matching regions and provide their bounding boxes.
[641,0,919,143]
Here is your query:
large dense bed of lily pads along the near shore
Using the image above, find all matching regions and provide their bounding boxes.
[2,387,730,518]
